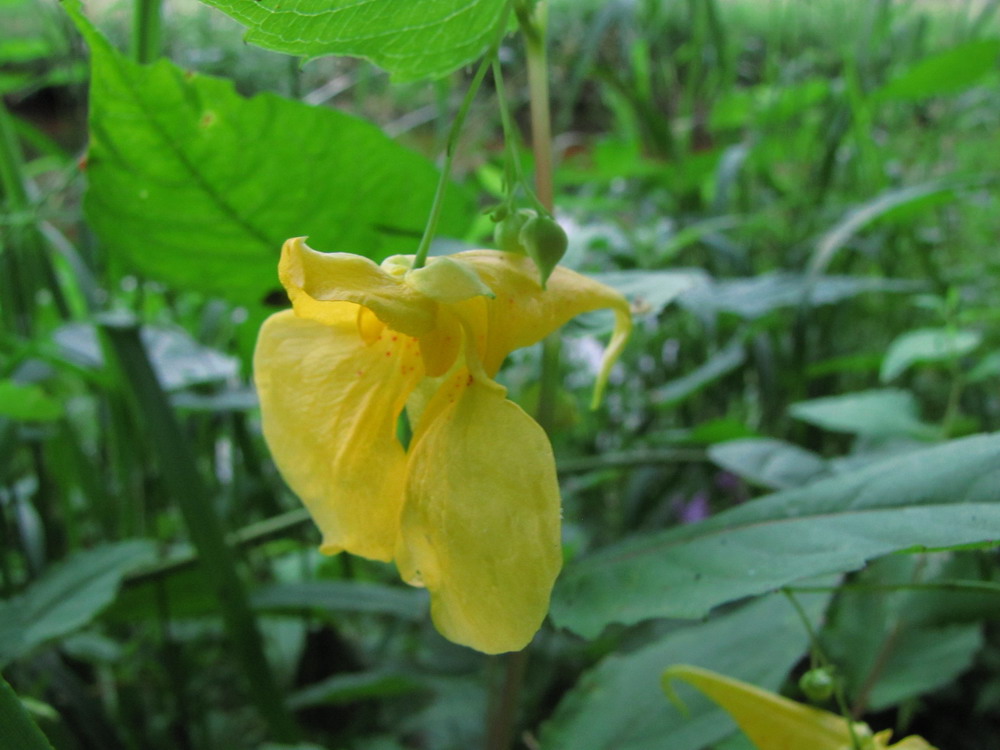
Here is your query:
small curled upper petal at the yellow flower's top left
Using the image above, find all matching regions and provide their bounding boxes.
[278,237,437,336]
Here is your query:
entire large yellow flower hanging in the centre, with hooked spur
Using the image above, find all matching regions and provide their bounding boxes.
[254,238,631,653]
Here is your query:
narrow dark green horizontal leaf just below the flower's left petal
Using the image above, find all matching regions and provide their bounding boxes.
[251,581,427,620]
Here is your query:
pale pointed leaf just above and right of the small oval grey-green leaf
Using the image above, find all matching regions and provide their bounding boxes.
[788,388,937,439]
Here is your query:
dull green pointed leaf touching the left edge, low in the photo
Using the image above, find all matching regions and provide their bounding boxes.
[0,539,155,664]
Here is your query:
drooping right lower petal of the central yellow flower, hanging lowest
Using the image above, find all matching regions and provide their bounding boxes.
[396,368,562,654]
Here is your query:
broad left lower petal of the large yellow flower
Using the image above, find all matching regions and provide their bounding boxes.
[254,302,423,561]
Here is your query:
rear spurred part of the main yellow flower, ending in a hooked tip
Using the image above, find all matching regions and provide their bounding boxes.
[452,250,632,397]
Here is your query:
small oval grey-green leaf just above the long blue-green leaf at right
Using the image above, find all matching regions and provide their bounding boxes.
[708,438,829,490]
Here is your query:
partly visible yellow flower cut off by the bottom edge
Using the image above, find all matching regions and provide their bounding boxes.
[663,664,936,750]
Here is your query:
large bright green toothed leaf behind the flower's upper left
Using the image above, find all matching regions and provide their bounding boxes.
[66,0,470,303]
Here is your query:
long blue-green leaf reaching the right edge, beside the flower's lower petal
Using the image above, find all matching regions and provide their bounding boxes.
[552,434,1000,637]
